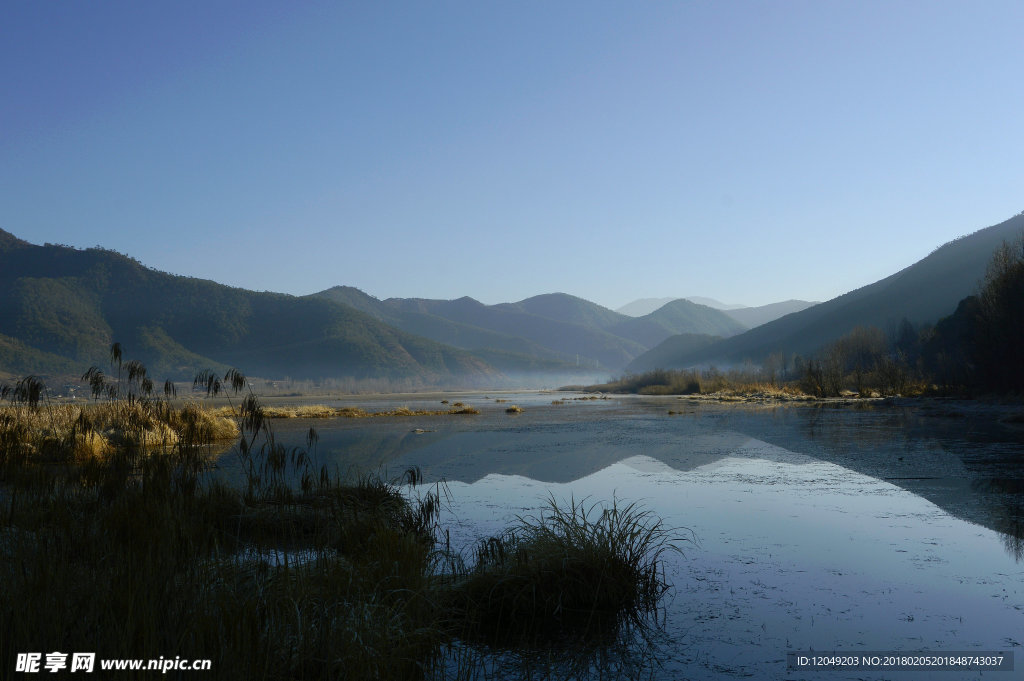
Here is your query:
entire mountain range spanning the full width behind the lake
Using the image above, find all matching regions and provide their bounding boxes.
[0,214,1024,387]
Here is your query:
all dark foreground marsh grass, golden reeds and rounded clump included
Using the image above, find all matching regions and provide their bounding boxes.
[6,350,688,680]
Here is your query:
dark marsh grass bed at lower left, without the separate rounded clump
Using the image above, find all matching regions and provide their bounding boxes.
[0,378,445,679]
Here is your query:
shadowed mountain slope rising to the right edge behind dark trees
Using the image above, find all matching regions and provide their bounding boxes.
[655,213,1024,366]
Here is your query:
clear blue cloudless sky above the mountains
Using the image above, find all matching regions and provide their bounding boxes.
[0,0,1024,307]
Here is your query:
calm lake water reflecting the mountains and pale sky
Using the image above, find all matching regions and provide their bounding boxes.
[211,392,1024,679]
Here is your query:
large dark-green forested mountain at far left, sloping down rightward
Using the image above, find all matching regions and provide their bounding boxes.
[0,230,499,381]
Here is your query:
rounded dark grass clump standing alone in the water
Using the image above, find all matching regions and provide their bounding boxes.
[451,498,691,647]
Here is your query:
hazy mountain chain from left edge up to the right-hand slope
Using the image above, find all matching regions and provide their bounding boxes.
[0,230,746,385]
